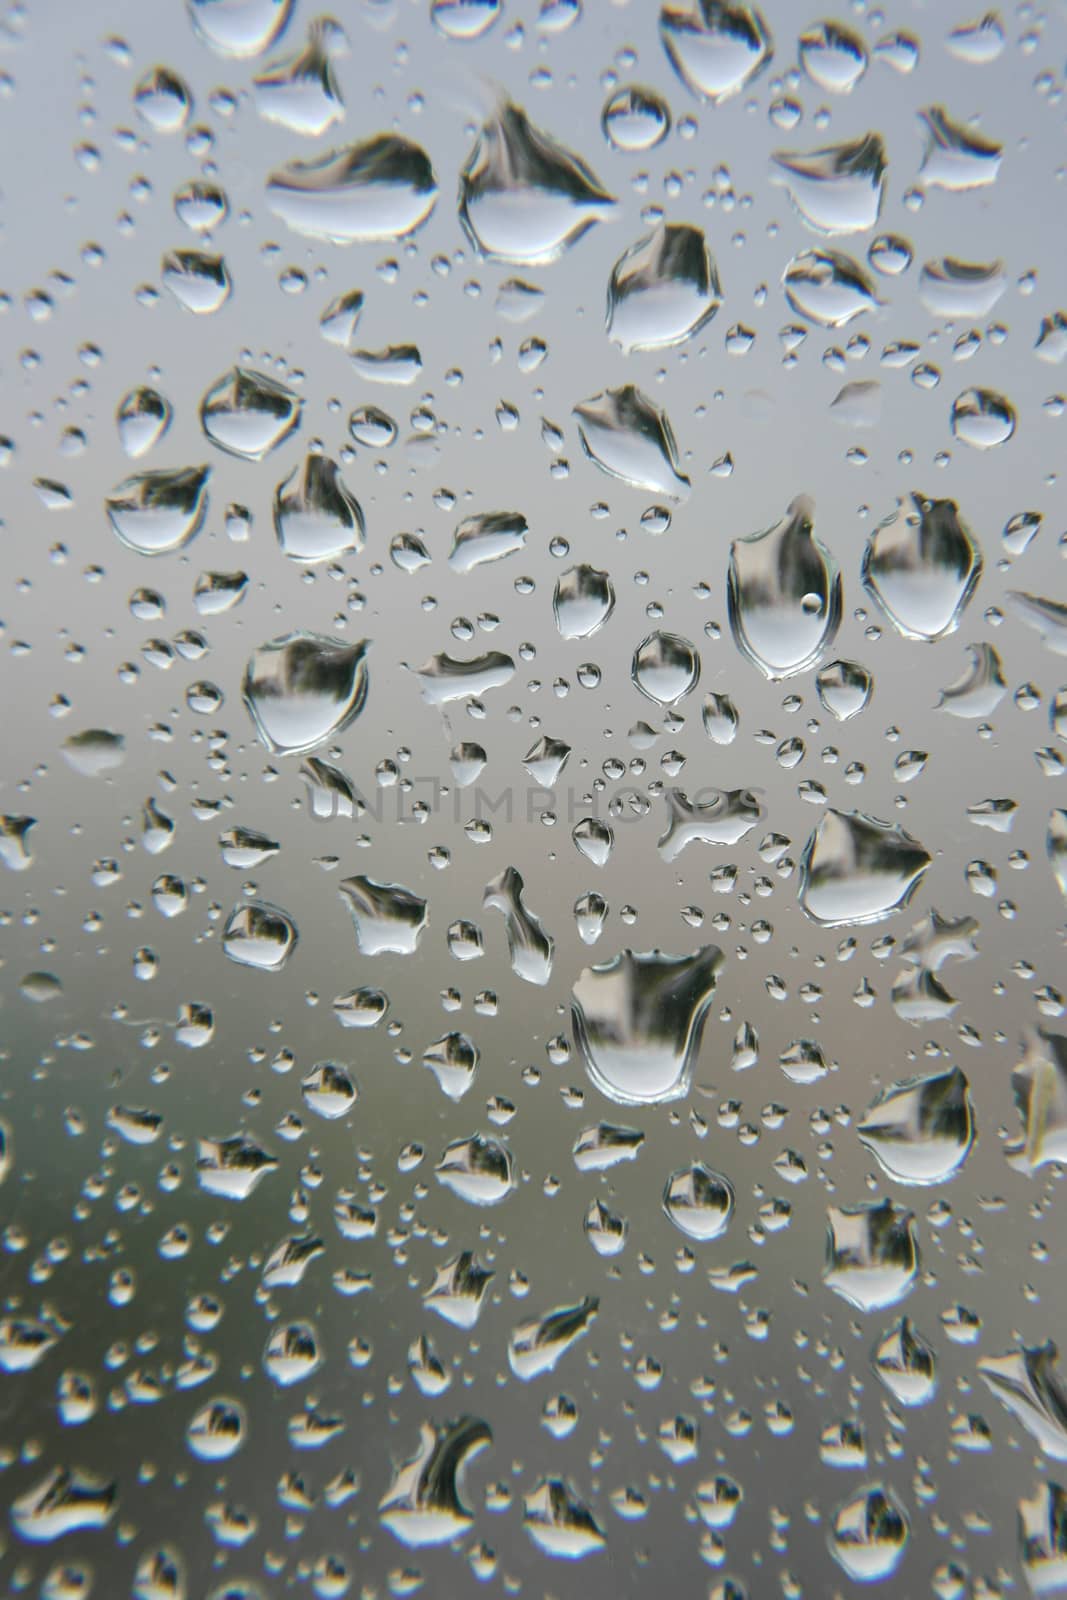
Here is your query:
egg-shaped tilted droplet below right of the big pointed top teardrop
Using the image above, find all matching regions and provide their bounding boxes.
[608,222,723,354]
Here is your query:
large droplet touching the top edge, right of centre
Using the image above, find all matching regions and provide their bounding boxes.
[659,0,774,104]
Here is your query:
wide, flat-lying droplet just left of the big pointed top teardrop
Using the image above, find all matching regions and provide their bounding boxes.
[267,133,437,245]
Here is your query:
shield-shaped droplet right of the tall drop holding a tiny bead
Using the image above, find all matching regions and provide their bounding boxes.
[862,494,982,640]
